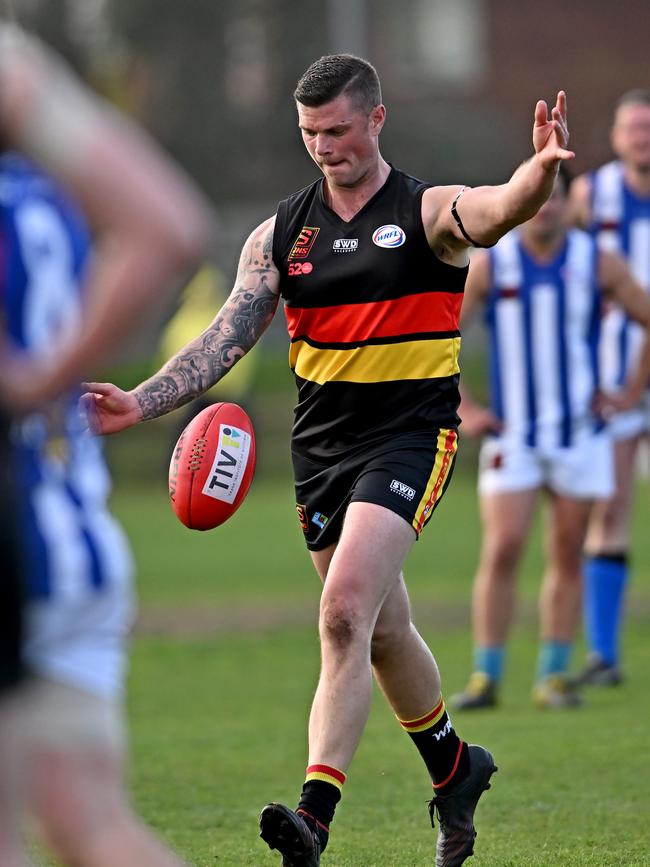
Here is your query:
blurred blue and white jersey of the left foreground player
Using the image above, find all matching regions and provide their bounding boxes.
[0,154,131,599]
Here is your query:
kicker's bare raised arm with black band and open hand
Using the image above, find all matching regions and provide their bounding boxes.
[423,90,574,260]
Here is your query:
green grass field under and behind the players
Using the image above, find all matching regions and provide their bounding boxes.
[90,471,650,867]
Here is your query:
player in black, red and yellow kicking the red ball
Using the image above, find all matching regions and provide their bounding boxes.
[81,55,573,867]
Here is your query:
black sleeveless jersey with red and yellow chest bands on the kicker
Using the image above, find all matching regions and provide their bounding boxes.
[273,168,467,461]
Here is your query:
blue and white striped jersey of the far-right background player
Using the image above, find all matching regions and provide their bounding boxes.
[590,161,650,390]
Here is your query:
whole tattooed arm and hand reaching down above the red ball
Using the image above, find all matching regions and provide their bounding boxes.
[82,217,279,434]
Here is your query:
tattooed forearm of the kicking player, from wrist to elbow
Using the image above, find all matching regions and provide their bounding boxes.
[132,287,278,421]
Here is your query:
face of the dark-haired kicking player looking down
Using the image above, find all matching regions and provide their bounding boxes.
[298,96,386,187]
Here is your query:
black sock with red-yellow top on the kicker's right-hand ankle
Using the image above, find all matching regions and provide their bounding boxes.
[398,697,469,792]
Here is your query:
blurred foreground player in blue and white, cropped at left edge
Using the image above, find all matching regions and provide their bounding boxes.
[0,24,210,867]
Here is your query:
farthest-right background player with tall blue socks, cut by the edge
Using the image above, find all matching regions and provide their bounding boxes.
[571,90,650,685]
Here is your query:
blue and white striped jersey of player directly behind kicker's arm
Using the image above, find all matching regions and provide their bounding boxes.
[486,230,601,448]
